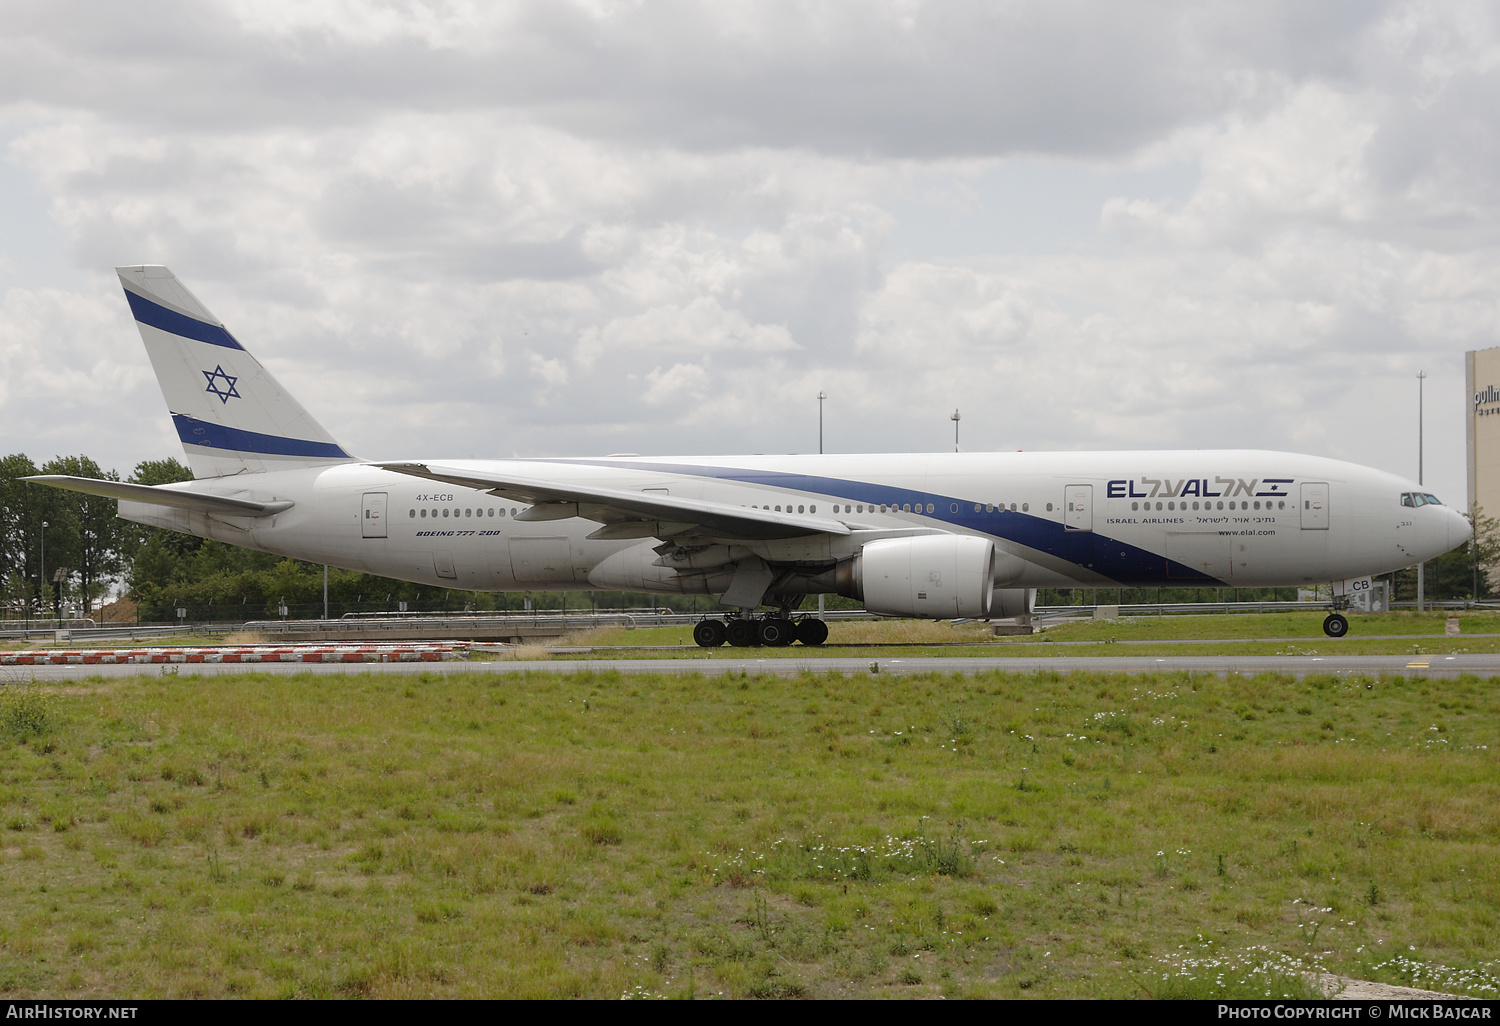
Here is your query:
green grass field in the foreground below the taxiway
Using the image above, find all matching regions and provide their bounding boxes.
[0,660,1500,998]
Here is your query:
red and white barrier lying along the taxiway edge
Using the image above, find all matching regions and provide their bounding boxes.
[0,642,470,666]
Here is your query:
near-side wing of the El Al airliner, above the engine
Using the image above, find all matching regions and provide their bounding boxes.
[374,464,851,542]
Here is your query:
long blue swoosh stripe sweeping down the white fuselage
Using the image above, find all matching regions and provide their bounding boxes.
[527,459,1226,587]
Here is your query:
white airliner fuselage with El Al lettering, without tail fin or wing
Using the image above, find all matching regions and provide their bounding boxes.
[120,450,1469,593]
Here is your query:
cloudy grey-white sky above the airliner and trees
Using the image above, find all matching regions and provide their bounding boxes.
[0,0,1500,504]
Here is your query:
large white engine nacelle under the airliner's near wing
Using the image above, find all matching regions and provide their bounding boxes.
[839,534,995,620]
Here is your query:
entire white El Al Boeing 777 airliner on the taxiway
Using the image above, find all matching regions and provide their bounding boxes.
[29,266,1470,647]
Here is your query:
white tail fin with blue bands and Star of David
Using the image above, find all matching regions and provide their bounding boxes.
[116,264,354,479]
